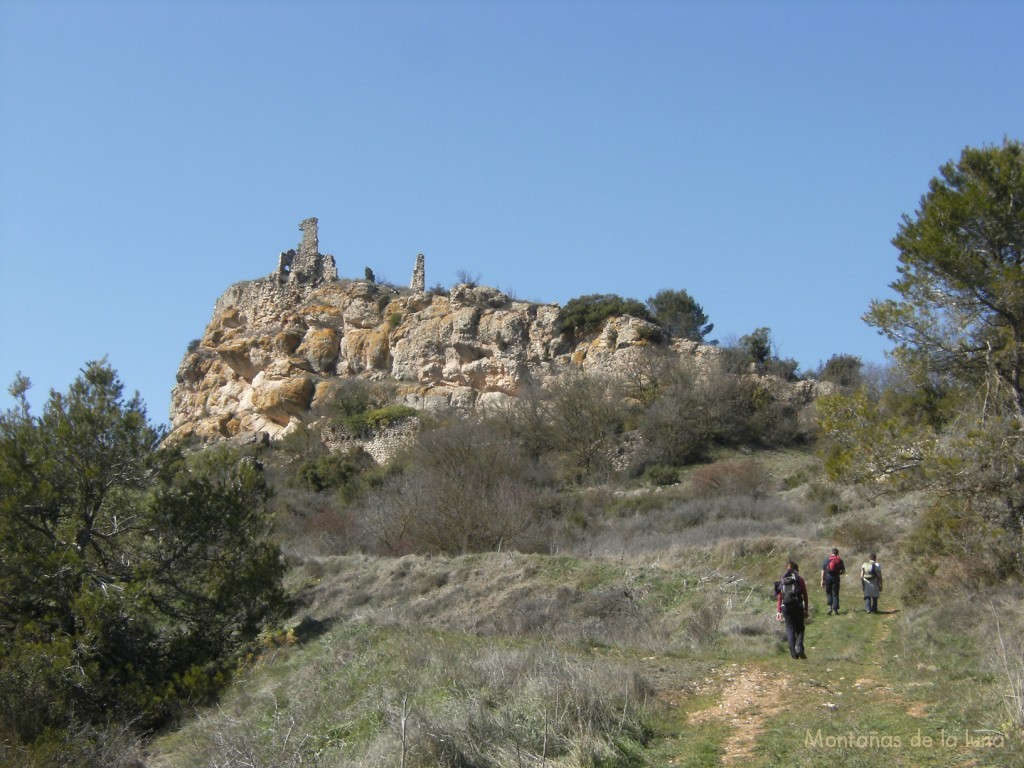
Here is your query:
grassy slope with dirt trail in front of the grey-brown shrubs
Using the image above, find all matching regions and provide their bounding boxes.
[147,455,1024,768]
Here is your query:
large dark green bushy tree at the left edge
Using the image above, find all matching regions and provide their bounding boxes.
[0,361,283,743]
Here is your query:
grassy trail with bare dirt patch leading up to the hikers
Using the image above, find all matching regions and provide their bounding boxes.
[652,589,1024,768]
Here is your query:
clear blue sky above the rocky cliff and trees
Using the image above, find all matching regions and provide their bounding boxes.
[0,0,1024,422]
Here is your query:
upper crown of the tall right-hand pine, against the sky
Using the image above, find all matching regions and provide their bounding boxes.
[864,140,1024,417]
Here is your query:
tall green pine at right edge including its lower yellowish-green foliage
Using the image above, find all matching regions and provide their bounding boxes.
[818,141,1024,583]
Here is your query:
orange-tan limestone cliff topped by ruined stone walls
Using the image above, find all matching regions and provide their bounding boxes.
[171,219,823,440]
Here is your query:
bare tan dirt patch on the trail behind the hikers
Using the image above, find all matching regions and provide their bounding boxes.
[690,665,791,765]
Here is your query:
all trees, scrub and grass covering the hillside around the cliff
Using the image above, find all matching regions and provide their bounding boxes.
[6,143,1024,768]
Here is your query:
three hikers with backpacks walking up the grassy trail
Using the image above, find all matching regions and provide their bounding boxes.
[775,547,882,658]
